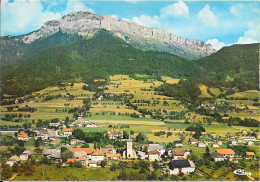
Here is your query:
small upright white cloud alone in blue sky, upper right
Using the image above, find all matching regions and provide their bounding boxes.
[198,4,218,28]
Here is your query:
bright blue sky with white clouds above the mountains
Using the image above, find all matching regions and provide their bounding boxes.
[1,0,260,50]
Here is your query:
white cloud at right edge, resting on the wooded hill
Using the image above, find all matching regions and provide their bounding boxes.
[236,22,260,44]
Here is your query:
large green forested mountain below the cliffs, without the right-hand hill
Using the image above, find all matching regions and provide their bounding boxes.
[2,29,197,95]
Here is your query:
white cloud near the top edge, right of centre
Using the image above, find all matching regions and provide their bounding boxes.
[161,0,189,18]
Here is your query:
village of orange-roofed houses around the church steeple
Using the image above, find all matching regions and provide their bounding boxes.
[1,116,259,181]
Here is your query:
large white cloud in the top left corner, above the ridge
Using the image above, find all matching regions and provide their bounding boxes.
[1,0,61,35]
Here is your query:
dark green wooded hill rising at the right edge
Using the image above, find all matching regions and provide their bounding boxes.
[194,43,260,91]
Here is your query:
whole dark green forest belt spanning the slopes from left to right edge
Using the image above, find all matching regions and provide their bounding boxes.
[1,29,259,96]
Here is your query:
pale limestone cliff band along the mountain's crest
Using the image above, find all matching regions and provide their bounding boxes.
[19,11,216,58]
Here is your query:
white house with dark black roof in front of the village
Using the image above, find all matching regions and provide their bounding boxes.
[167,159,195,174]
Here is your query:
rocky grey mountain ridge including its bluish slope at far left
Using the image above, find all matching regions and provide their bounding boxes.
[0,11,215,67]
